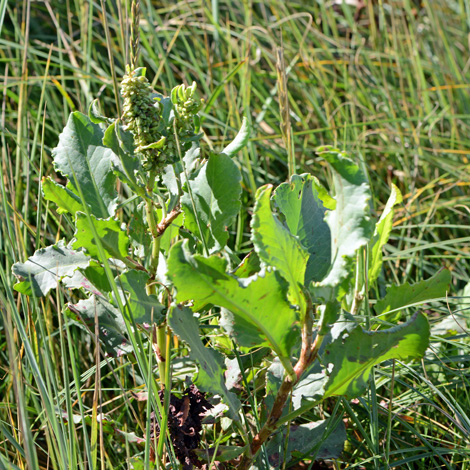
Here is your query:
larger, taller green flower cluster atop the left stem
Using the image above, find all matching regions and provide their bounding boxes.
[121,67,168,171]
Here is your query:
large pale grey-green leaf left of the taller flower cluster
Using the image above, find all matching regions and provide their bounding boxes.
[52,112,117,218]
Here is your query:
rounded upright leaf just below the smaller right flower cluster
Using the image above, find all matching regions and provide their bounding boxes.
[181,154,242,253]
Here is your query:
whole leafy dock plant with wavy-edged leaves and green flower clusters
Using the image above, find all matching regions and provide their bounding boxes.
[13,3,450,469]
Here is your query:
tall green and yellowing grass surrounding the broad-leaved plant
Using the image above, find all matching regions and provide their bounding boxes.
[0,0,470,470]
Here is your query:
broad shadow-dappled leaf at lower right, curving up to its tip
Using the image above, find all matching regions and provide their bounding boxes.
[321,313,429,399]
